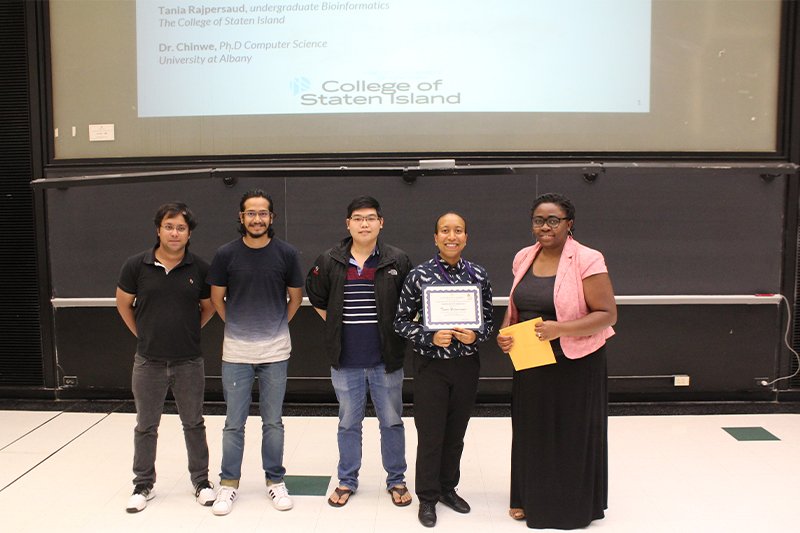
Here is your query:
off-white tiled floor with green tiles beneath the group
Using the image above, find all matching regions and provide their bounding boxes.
[0,411,800,533]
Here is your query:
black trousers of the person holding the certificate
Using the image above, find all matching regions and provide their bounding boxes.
[414,354,480,503]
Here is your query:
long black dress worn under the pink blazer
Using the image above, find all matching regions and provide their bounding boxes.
[511,273,608,529]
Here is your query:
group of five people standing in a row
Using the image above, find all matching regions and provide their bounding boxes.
[116,189,616,529]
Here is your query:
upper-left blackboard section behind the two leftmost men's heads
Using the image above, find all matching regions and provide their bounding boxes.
[47,178,286,298]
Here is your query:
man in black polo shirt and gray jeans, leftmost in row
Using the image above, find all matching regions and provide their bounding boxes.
[116,202,215,513]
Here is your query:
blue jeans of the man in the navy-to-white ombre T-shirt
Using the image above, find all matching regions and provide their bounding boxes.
[220,360,289,487]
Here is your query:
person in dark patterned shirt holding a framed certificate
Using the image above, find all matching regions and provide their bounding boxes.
[394,212,492,527]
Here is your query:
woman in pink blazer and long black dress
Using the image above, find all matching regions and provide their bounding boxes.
[497,193,617,529]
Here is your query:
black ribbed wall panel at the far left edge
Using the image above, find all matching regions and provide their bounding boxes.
[0,1,44,387]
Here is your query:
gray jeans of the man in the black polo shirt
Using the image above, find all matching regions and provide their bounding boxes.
[132,354,208,487]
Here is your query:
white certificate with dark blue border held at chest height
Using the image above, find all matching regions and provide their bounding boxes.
[422,284,483,331]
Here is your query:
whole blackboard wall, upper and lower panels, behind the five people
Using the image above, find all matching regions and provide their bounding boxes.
[42,168,786,401]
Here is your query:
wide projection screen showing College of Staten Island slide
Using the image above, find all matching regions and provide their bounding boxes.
[48,0,786,163]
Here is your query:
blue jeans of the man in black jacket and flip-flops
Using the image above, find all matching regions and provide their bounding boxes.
[331,365,406,491]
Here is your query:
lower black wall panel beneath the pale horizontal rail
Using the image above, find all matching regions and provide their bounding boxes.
[55,305,782,402]
